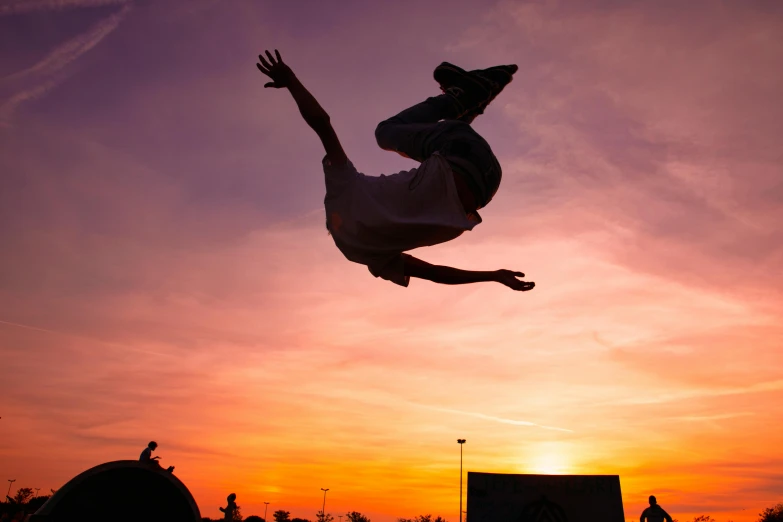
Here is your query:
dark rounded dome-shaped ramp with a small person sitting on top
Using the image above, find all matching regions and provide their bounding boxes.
[27,460,201,522]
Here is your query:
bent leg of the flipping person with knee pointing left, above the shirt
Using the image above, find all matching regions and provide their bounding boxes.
[375,94,458,162]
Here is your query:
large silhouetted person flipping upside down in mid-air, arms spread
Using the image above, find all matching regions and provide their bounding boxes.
[256,50,535,290]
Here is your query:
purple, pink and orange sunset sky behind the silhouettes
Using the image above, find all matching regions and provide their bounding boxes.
[0,0,783,522]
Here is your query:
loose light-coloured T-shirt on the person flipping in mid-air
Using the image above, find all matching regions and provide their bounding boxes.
[323,153,481,286]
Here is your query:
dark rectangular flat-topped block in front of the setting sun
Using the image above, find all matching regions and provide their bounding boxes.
[466,471,625,522]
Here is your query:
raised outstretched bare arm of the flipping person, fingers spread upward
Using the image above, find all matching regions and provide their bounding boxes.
[256,49,348,166]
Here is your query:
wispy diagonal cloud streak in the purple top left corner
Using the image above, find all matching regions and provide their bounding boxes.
[0,2,131,125]
